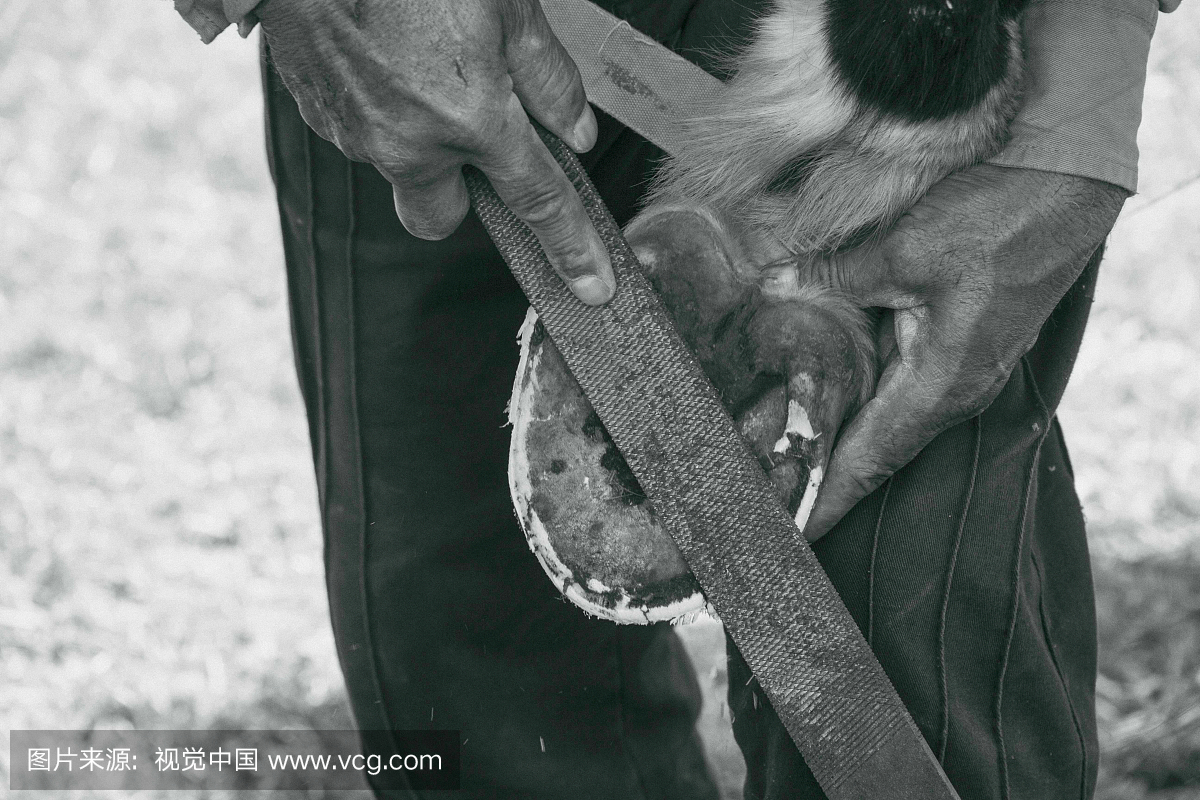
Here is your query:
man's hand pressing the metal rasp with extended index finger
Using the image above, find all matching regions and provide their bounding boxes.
[257,0,616,305]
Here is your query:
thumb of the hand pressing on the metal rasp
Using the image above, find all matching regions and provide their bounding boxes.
[505,0,598,152]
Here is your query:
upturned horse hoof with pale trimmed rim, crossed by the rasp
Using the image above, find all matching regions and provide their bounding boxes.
[509,207,860,624]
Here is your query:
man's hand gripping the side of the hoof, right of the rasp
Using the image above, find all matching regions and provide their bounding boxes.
[800,164,1126,541]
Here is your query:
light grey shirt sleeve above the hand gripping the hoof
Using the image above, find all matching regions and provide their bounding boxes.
[988,0,1170,193]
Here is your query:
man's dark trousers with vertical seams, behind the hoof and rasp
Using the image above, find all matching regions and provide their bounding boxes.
[264,0,1097,800]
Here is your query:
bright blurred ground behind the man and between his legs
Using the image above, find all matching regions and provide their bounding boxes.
[0,0,1200,800]
